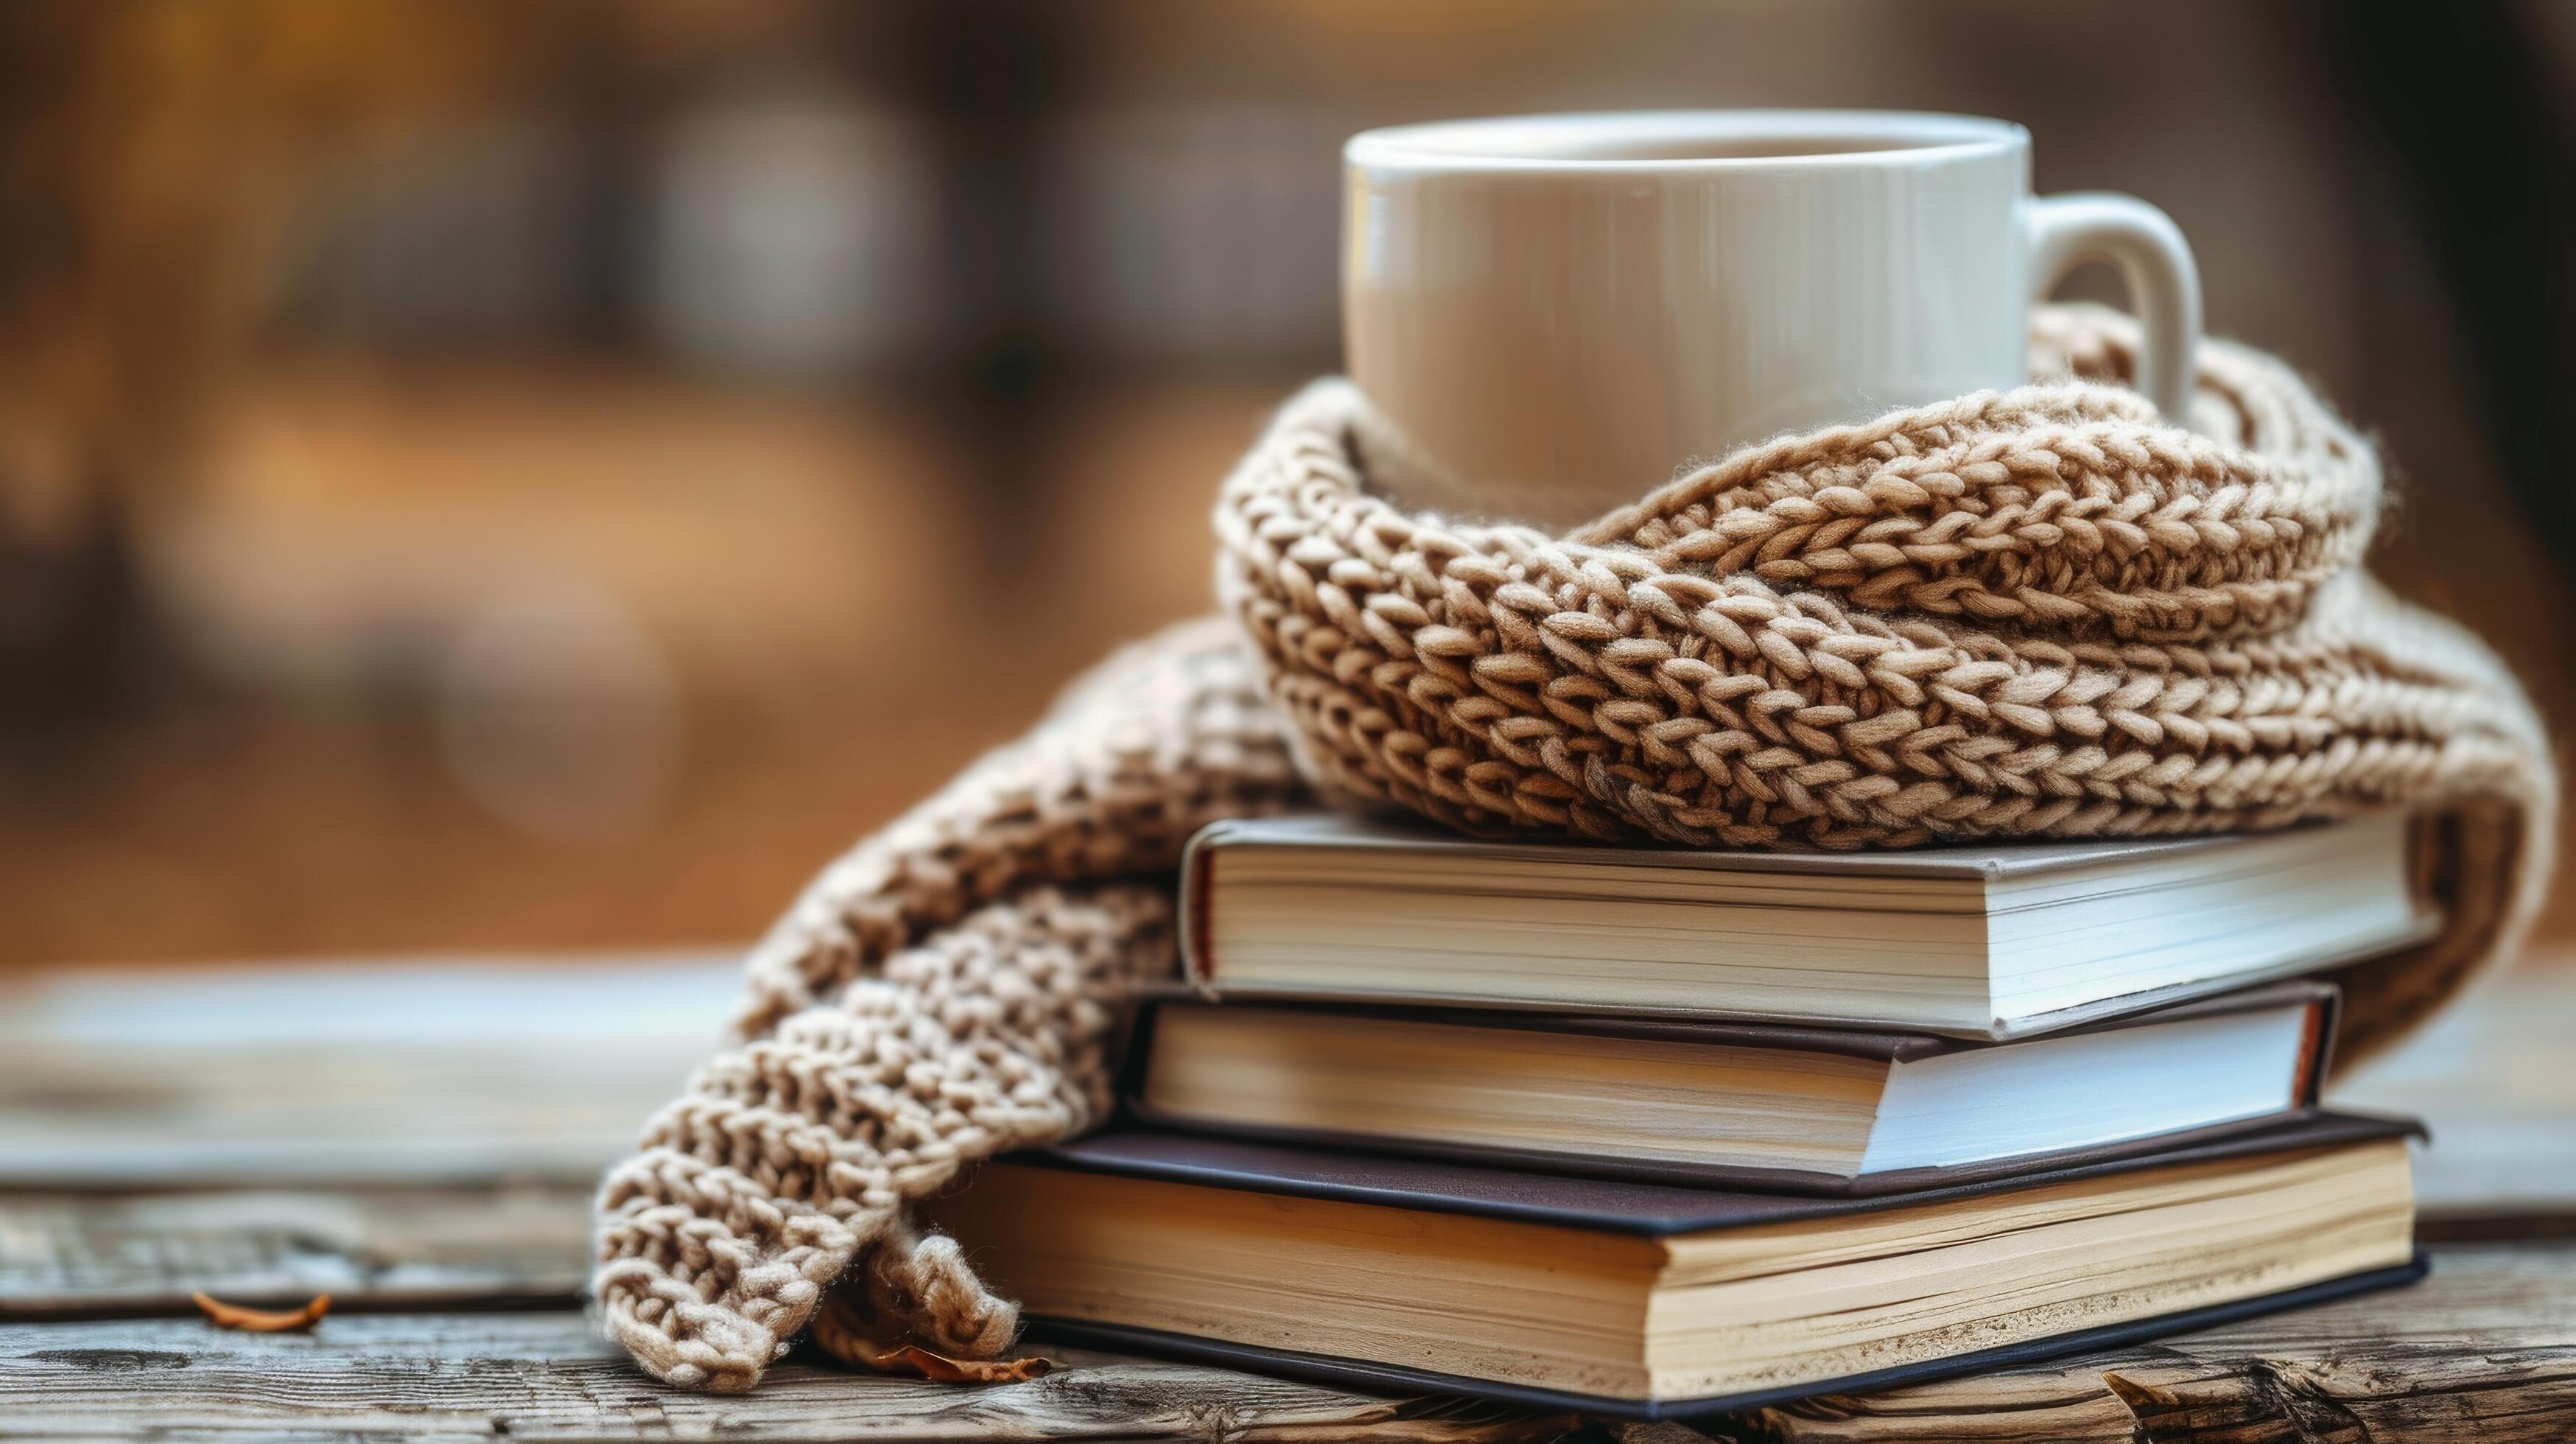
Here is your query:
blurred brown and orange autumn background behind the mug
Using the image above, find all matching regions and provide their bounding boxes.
[0,0,2576,964]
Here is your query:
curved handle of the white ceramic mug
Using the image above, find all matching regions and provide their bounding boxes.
[2025,191,2200,426]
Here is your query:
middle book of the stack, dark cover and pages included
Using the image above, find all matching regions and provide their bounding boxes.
[1129,983,2337,1194]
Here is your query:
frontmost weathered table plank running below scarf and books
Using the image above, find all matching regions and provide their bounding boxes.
[0,1246,2576,1444]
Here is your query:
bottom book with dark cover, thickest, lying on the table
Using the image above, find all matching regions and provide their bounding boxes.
[933,1114,2421,1418]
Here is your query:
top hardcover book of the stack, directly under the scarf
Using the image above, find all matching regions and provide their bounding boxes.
[1182,815,2437,1040]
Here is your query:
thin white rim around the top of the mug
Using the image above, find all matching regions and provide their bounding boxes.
[1342,108,2030,175]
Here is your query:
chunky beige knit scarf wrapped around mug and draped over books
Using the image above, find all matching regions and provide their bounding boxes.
[595,312,2555,1390]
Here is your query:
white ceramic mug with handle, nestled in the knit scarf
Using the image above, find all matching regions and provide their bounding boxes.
[1342,111,2200,526]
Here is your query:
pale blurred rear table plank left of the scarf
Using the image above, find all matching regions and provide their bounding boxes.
[0,954,737,1189]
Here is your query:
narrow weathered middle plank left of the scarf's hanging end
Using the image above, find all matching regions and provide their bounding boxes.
[0,1184,590,1320]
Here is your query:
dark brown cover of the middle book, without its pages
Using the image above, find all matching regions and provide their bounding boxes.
[1120,980,2342,1196]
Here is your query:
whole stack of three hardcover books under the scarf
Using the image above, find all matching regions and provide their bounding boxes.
[933,818,2432,1418]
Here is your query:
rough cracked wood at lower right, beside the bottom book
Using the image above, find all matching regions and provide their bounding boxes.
[1708,1243,2576,1444]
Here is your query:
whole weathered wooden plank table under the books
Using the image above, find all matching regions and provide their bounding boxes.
[0,957,2576,1444]
